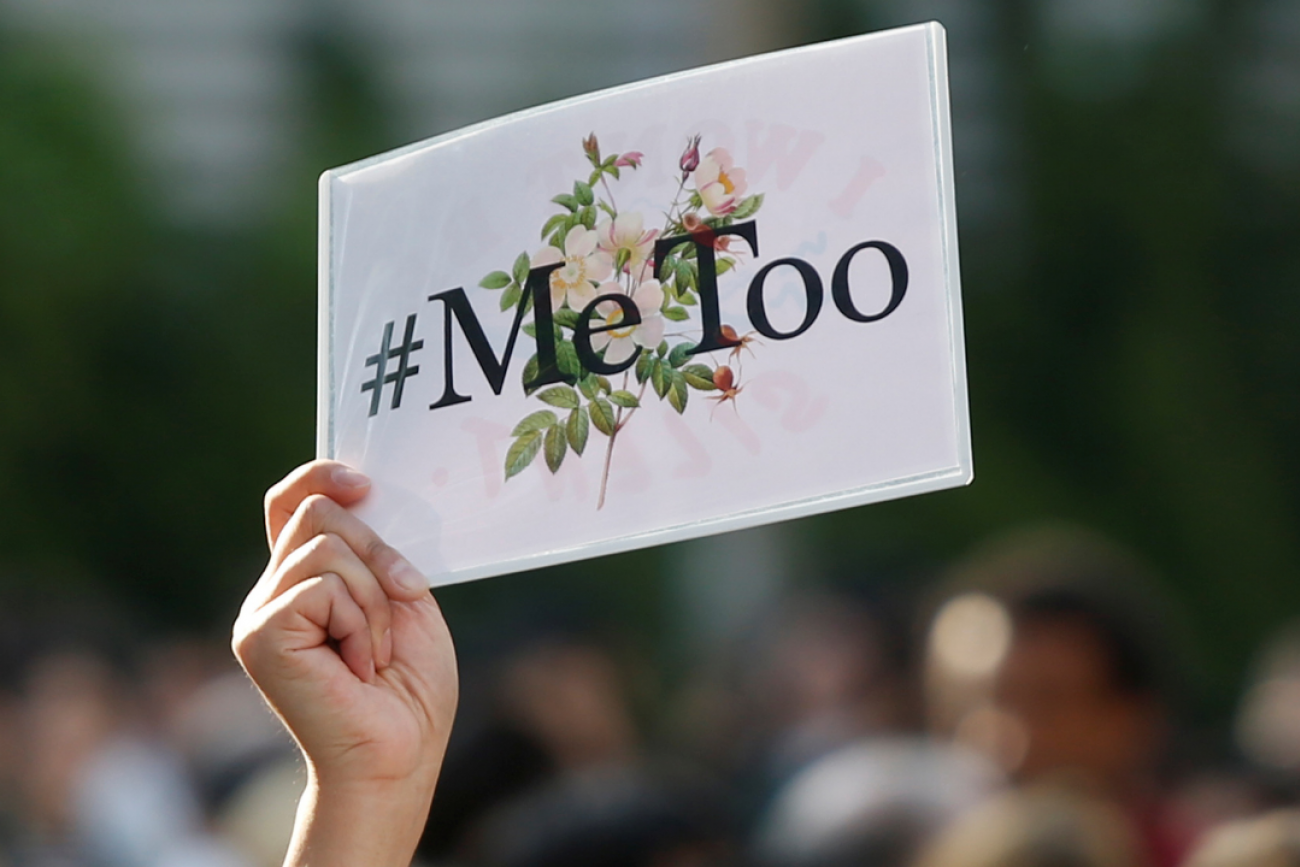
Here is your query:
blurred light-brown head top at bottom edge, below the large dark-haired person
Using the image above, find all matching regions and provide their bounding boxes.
[915,785,1141,867]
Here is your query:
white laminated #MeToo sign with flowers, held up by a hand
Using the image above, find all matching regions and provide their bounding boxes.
[319,23,972,584]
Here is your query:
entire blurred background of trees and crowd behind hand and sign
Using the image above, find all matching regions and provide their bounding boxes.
[0,0,1300,867]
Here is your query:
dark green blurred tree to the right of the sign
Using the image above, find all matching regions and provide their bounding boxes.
[814,0,1300,702]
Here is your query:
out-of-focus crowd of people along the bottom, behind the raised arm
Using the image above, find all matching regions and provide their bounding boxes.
[0,528,1300,867]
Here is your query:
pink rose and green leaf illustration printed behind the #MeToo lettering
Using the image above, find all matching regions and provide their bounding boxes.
[480,133,763,508]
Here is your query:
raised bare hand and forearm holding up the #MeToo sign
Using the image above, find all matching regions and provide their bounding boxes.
[231,460,458,867]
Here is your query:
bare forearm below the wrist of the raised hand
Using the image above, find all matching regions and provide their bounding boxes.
[285,772,436,867]
